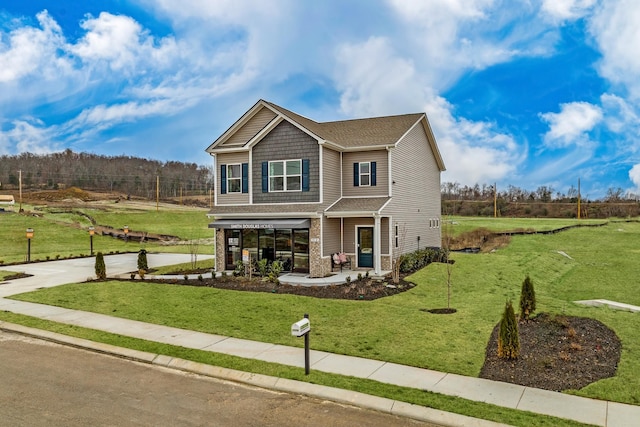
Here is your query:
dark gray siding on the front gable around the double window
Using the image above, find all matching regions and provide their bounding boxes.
[251,121,320,203]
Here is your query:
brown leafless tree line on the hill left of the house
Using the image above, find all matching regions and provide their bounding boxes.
[0,149,213,199]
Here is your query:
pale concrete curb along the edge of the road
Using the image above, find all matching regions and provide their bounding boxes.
[0,321,509,427]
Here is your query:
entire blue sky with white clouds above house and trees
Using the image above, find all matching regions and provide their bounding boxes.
[0,0,640,199]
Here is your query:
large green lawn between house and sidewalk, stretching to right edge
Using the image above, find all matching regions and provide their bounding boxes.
[0,213,640,425]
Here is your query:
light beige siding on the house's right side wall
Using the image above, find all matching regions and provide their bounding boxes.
[383,122,441,253]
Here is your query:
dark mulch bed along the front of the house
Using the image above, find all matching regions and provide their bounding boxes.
[150,274,415,301]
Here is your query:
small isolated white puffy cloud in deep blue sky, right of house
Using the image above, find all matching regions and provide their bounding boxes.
[540,102,603,148]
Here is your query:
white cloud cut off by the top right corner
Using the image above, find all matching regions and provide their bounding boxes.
[589,0,640,99]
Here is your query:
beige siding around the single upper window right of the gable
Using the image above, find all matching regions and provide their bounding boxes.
[342,150,389,197]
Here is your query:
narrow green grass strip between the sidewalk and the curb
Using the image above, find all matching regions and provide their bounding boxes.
[0,311,584,427]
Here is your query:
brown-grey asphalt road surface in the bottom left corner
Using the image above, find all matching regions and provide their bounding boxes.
[0,332,434,427]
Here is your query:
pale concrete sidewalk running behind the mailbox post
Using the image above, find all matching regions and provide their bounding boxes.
[0,255,640,427]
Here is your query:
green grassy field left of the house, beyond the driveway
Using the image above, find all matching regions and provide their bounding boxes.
[0,203,213,265]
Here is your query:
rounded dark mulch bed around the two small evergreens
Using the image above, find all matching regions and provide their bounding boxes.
[480,313,622,391]
